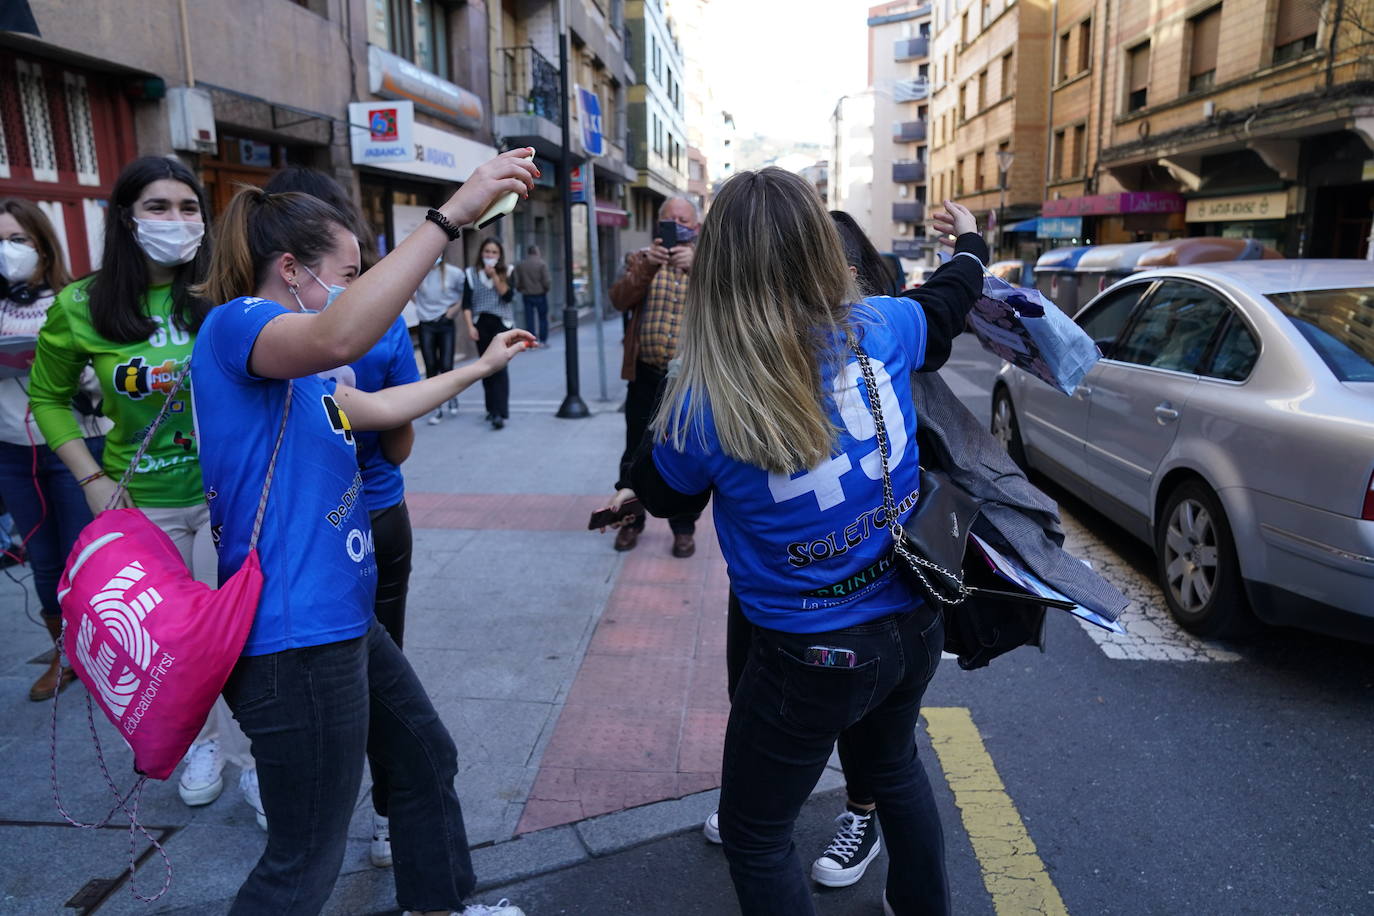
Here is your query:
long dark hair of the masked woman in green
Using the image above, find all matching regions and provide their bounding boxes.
[89,155,213,343]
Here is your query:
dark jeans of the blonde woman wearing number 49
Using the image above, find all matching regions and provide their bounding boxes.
[720,607,949,916]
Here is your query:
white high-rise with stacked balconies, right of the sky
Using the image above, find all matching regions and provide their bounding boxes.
[868,0,933,258]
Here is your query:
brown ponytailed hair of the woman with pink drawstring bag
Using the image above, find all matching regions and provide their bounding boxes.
[196,187,352,305]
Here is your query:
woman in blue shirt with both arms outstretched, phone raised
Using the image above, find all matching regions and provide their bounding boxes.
[192,150,537,916]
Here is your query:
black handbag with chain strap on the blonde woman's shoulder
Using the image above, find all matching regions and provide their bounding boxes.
[849,334,1049,670]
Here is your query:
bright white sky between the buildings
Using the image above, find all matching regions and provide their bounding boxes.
[701,0,881,143]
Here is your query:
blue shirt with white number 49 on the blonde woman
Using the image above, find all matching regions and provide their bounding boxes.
[654,297,926,633]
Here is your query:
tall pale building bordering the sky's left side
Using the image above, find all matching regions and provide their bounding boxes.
[625,0,687,247]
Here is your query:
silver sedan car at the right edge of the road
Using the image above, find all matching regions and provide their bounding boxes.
[992,260,1374,640]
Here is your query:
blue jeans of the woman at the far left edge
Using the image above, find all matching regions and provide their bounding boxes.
[0,437,104,617]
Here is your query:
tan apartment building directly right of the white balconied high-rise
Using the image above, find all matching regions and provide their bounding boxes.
[927,0,1051,255]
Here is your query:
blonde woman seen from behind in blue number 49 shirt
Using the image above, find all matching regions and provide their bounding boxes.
[632,169,987,916]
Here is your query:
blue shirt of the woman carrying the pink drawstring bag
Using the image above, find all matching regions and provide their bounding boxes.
[192,298,376,655]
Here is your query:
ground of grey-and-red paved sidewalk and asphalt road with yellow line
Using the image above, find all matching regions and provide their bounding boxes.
[0,321,1374,916]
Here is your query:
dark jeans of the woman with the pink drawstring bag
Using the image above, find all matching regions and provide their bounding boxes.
[224,623,477,916]
